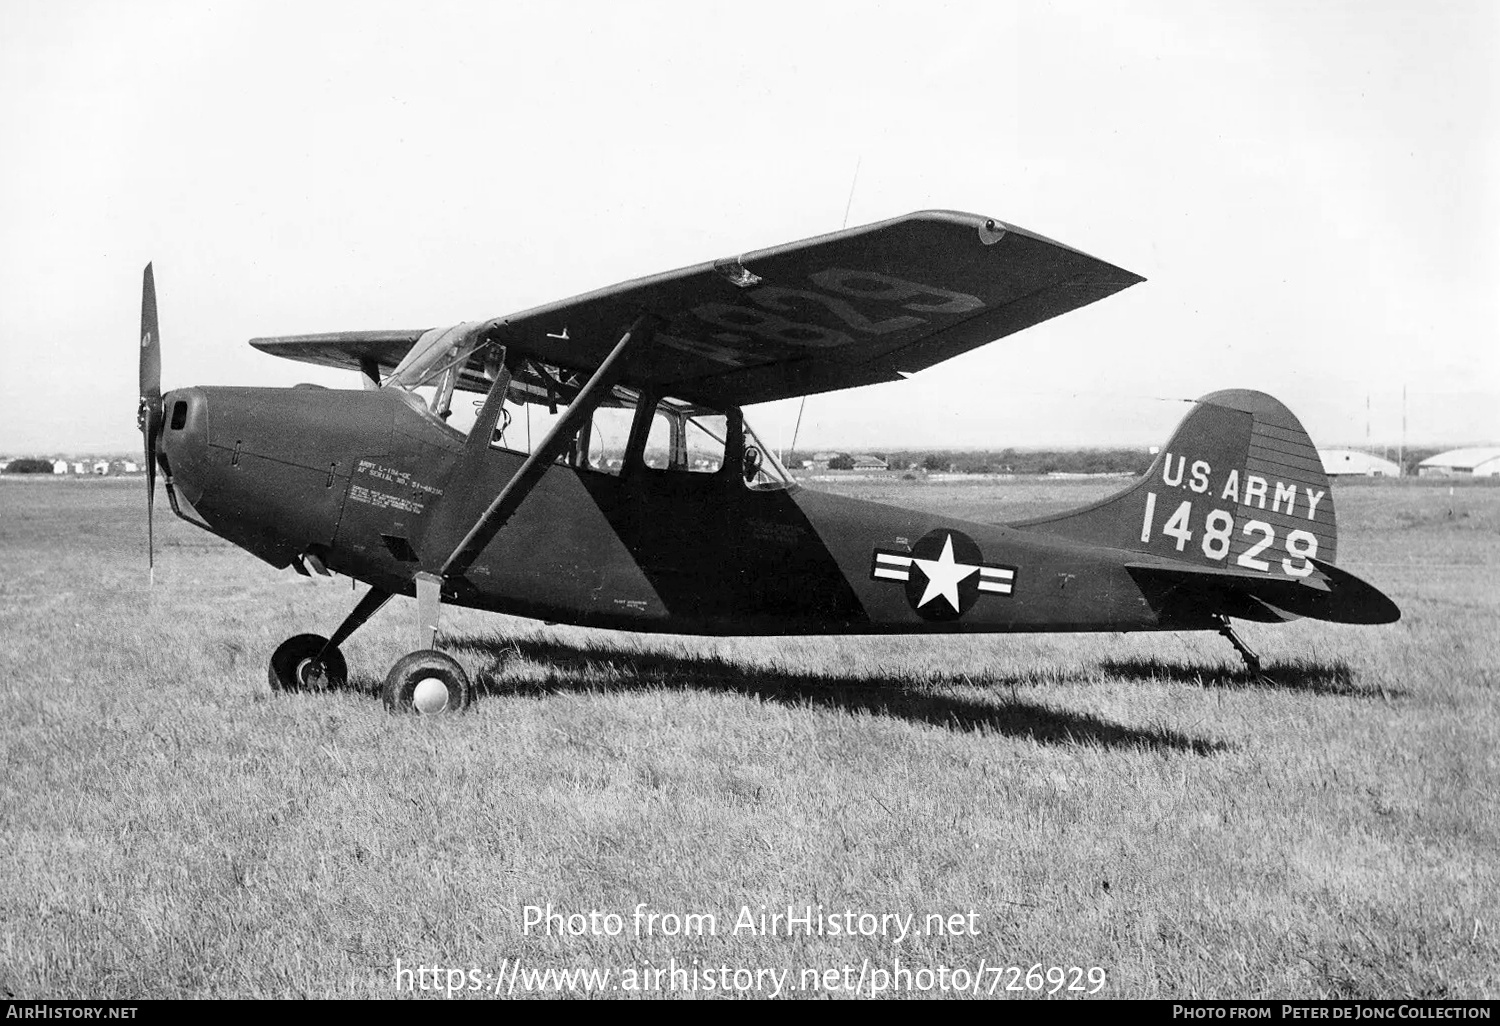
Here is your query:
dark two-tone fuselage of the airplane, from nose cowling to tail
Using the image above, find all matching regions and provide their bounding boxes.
[152,387,1214,635]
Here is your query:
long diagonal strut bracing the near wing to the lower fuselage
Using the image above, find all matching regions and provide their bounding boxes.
[438,315,656,581]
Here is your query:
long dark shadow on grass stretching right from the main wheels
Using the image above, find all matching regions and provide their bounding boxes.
[334,639,1232,756]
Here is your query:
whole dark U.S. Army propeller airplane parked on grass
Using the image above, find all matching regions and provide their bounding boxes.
[138,210,1400,714]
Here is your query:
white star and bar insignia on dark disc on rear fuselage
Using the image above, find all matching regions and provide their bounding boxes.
[870,530,1016,620]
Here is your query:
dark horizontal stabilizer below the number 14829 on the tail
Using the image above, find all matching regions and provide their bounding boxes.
[1125,560,1401,624]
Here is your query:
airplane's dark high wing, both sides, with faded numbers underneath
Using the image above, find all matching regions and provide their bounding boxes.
[251,210,1145,405]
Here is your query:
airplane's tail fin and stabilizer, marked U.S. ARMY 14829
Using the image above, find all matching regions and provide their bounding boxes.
[1014,389,1400,623]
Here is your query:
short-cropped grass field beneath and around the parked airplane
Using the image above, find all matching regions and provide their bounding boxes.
[0,480,1500,998]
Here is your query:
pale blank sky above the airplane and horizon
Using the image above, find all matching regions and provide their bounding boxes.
[0,0,1500,455]
